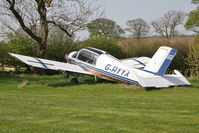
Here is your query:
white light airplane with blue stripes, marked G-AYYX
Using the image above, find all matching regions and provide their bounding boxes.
[9,46,191,88]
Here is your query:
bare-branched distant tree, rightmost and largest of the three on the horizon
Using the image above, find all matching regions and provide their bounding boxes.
[151,11,185,38]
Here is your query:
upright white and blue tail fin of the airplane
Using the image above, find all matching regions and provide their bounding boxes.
[144,46,177,76]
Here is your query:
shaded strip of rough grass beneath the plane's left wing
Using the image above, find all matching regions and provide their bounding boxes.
[0,71,118,87]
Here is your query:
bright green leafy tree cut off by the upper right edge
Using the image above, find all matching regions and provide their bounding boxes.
[184,0,199,33]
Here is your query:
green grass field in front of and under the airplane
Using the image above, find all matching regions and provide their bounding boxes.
[0,72,199,133]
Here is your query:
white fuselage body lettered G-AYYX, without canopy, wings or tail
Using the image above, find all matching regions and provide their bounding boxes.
[68,52,138,84]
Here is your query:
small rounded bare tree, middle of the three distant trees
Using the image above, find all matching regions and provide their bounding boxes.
[126,18,150,39]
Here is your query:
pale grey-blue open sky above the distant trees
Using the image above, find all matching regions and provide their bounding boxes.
[79,0,196,39]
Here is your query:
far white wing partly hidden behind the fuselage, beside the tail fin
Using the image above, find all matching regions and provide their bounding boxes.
[120,57,151,68]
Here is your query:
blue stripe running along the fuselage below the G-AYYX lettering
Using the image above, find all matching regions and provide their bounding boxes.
[70,59,138,84]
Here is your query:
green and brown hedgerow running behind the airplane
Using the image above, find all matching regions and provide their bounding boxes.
[0,32,194,77]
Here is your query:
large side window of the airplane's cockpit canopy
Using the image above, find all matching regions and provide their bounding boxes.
[77,50,98,64]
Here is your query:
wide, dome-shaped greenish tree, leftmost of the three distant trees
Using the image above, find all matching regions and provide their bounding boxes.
[87,18,124,38]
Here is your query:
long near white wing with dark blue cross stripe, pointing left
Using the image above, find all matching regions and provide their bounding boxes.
[9,53,93,75]
